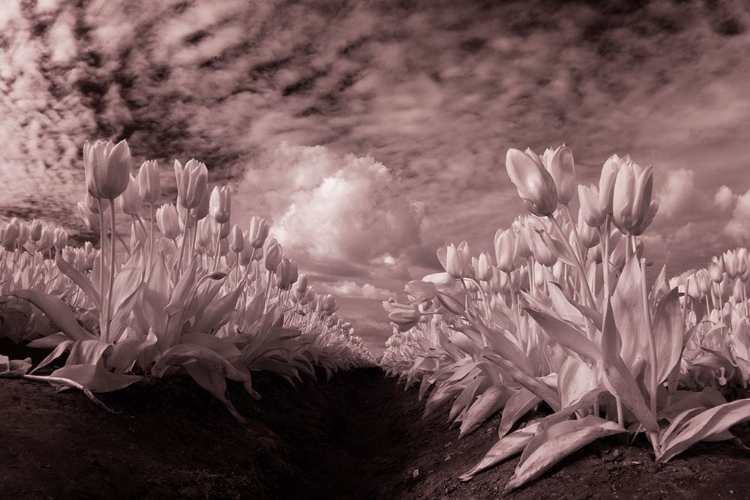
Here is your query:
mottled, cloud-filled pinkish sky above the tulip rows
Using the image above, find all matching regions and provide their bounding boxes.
[0,0,750,352]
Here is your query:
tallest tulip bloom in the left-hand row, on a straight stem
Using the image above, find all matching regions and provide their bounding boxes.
[83,140,130,200]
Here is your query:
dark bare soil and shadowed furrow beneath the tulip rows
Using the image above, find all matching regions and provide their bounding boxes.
[0,345,750,500]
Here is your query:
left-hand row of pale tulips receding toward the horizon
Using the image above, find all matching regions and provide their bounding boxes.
[0,141,374,420]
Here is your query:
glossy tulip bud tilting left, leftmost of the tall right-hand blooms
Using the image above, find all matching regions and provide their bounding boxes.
[505,149,557,217]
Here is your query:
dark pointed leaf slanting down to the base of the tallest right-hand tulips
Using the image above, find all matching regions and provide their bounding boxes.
[602,303,659,432]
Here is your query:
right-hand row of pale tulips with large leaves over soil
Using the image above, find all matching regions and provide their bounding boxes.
[381,146,750,490]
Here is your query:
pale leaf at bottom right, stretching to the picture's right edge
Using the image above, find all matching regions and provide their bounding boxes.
[657,399,750,462]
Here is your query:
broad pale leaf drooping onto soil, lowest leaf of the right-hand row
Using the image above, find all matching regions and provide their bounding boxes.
[505,415,626,492]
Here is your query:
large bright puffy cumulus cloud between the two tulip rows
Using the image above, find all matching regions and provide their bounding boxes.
[235,143,432,272]
